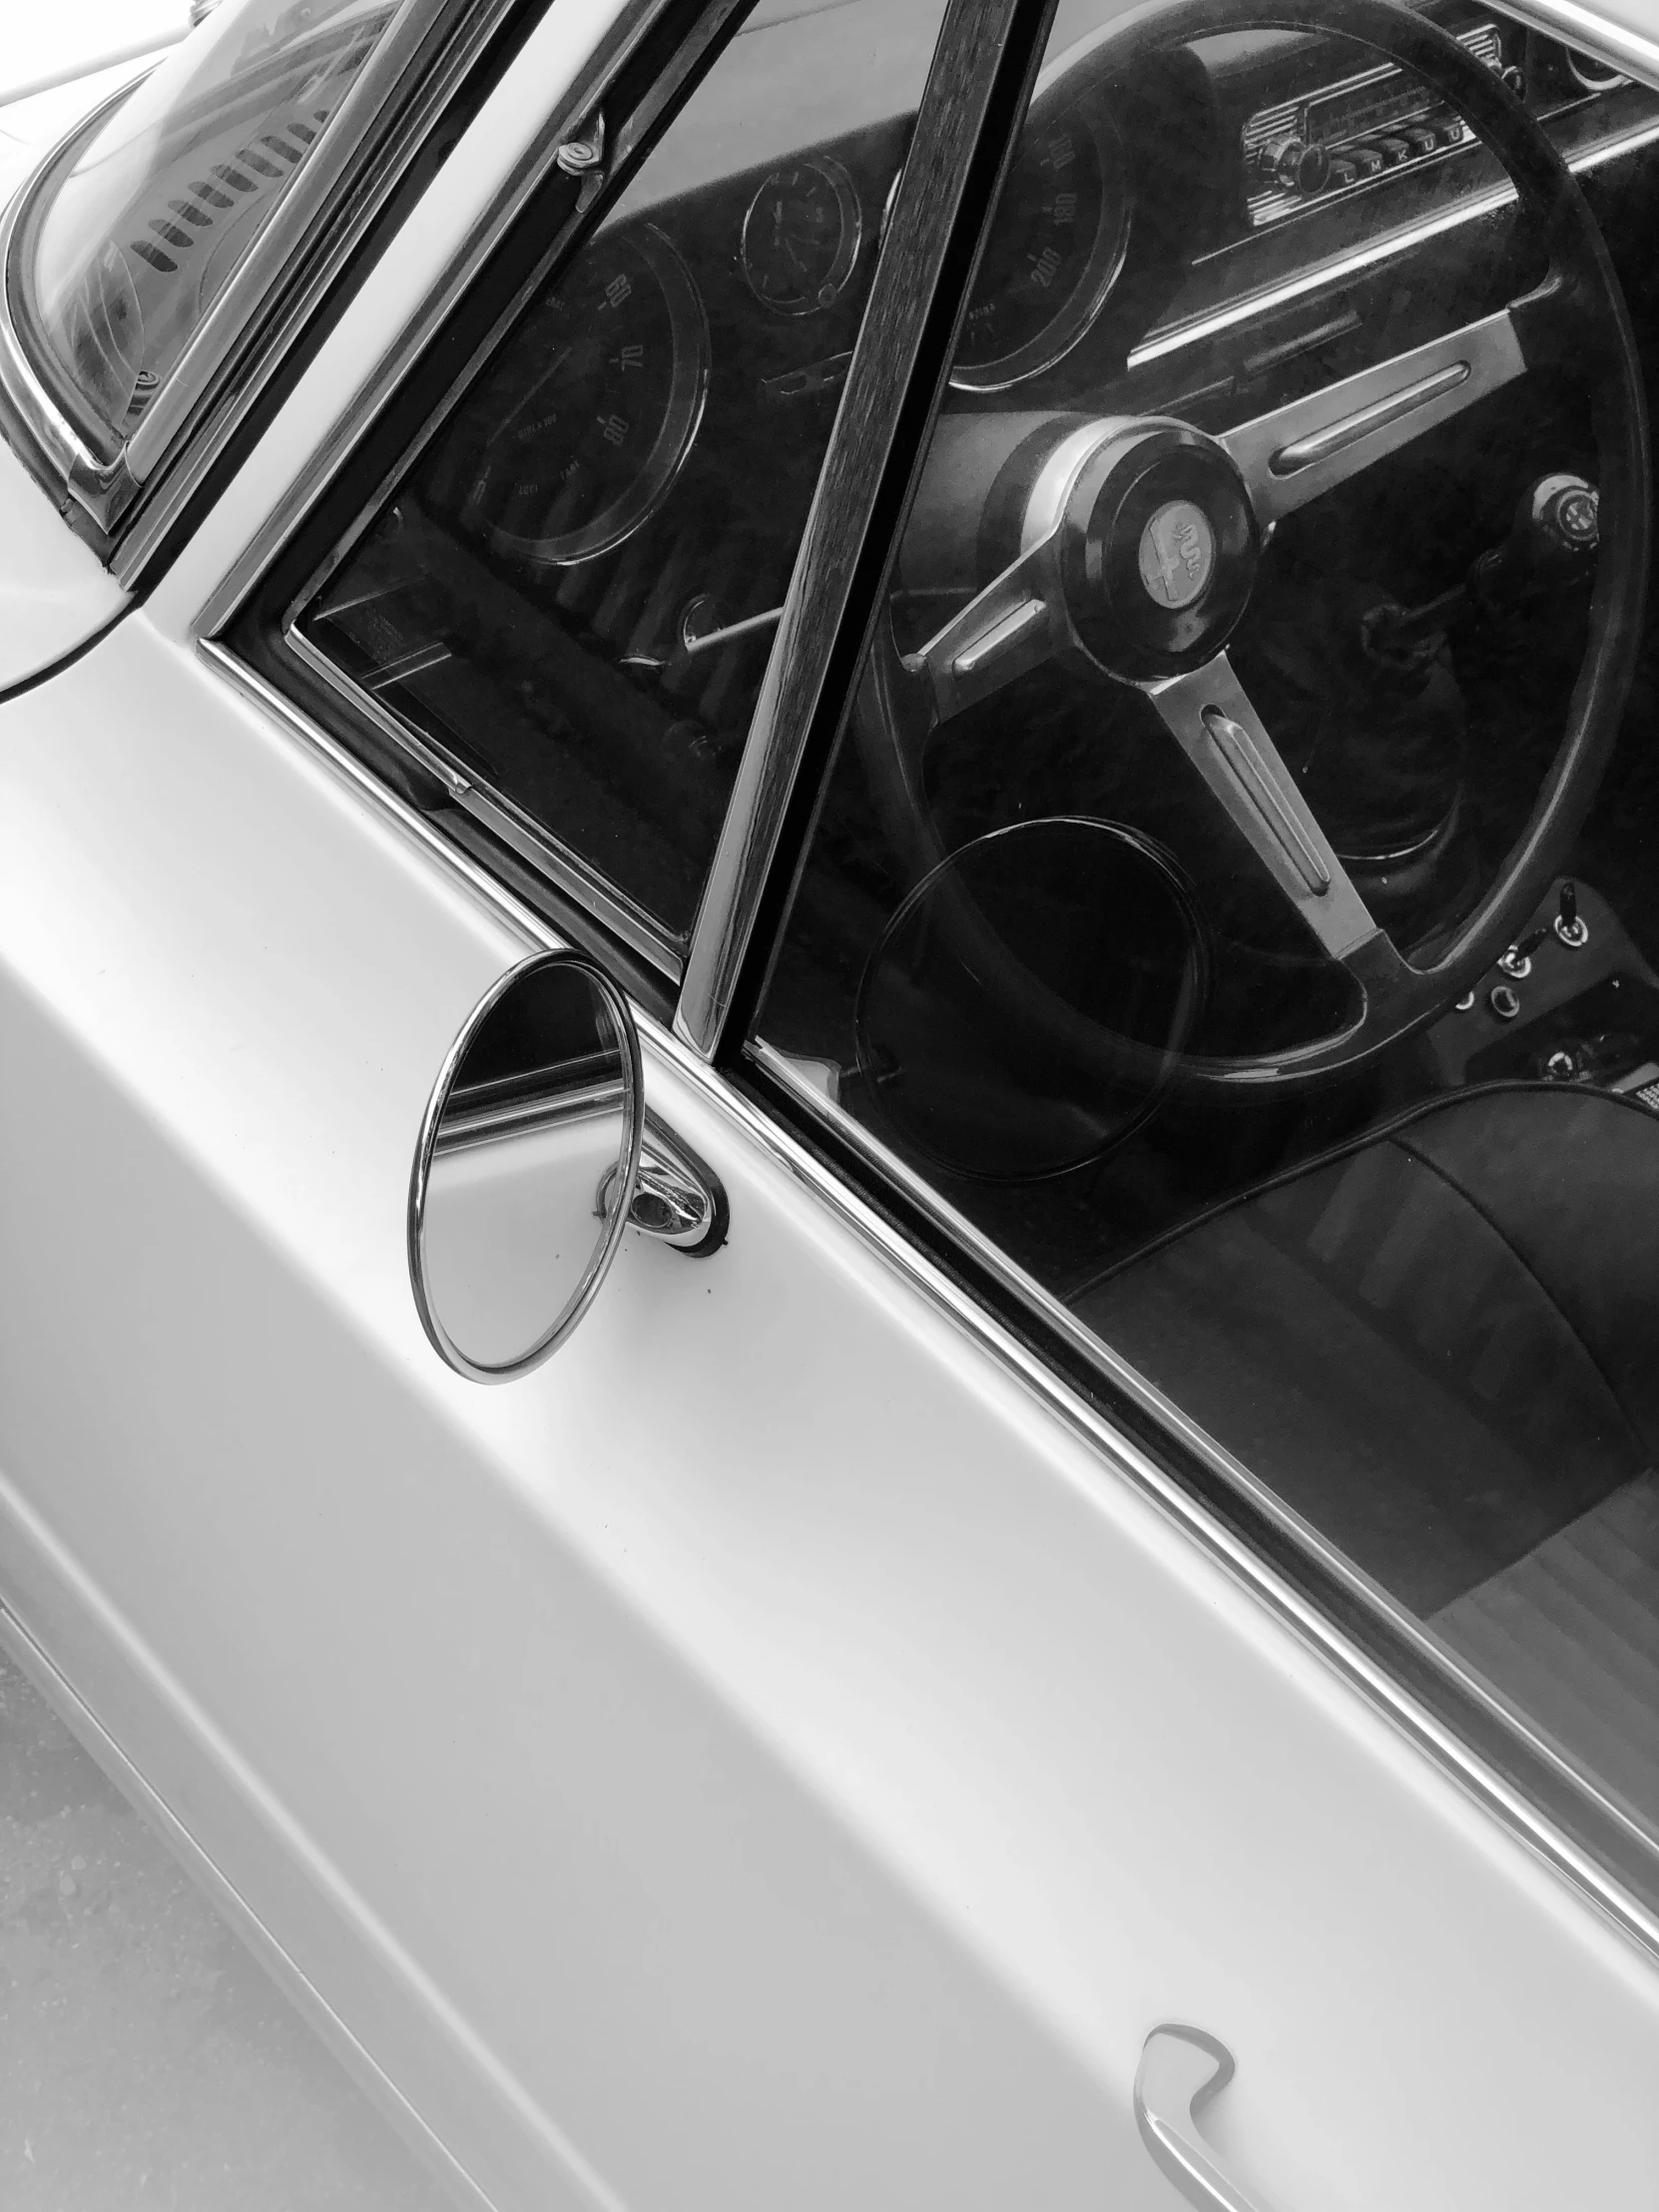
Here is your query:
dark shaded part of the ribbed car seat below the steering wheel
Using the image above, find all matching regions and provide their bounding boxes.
[1073,1084,1659,1617]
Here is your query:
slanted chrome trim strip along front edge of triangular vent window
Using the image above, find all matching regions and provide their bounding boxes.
[193,0,712,637]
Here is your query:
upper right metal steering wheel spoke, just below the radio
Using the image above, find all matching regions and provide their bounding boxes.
[1219,307,1544,529]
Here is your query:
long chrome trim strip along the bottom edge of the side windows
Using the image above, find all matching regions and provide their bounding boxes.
[197,639,1659,1959]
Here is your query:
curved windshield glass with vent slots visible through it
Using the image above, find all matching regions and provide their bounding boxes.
[11,0,396,453]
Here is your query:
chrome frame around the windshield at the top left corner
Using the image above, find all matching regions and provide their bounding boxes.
[0,0,535,548]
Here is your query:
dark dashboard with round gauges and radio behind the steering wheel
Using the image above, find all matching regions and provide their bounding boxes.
[422,9,1659,632]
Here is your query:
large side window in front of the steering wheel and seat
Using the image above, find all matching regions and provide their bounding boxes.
[752,7,1659,1876]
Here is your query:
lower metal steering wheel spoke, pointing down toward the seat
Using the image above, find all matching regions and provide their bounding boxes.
[1146,653,1398,977]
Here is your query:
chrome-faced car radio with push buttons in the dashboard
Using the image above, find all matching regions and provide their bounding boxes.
[1241,22,1522,230]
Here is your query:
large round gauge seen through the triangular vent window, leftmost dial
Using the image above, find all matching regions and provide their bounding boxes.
[464,224,708,564]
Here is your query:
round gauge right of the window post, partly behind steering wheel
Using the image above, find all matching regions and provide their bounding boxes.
[951,104,1133,391]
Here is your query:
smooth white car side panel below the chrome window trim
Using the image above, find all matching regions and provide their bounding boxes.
[0,615,1659,2212]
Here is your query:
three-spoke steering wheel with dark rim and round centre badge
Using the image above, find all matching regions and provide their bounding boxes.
[853,0,1650,1095]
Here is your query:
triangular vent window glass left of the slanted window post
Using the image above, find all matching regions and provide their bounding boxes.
[292,0,942,962]
